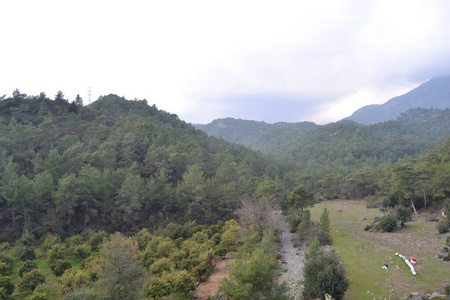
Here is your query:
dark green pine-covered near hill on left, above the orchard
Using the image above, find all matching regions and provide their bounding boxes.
[0,90,292,240]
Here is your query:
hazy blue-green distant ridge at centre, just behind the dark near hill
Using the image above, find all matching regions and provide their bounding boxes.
[194,118,317,152]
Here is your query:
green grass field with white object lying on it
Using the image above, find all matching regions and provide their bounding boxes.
[311,200,450,299]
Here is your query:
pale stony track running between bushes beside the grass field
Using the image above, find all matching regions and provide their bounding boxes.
[273,210,306,299]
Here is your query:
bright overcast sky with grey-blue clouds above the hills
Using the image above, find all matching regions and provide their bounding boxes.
[0,0,450,124]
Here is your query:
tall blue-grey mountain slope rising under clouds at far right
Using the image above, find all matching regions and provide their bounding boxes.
[344,76,450,125]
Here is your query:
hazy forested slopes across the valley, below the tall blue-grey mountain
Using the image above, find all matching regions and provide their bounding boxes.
[201,109,450,194]
